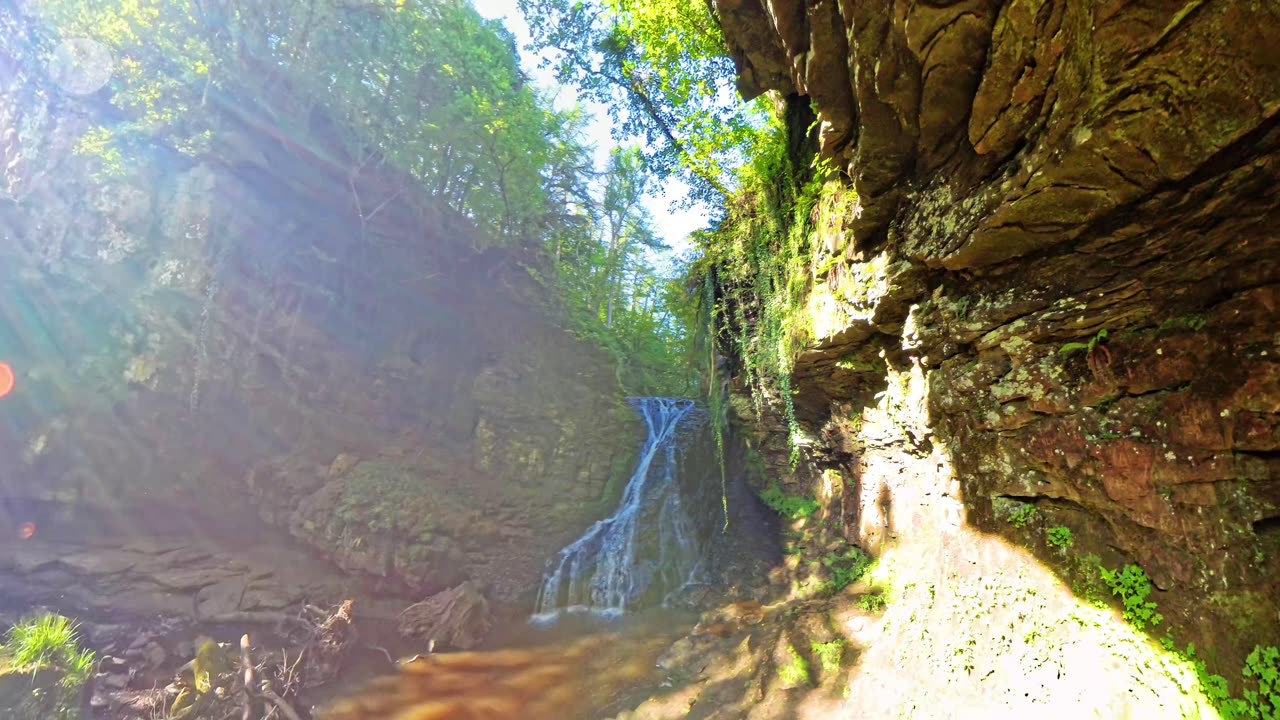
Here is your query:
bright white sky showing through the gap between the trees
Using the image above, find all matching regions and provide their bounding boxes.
[471,0,707,254]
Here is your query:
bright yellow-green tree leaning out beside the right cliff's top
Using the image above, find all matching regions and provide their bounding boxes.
[520,0,763,206]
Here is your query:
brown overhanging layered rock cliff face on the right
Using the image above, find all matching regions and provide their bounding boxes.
[717,0,1280,661]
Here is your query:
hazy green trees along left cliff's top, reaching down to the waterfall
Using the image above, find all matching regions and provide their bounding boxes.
[20,0,701,395]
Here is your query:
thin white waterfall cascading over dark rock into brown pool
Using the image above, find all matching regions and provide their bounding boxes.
[534,397,703,619]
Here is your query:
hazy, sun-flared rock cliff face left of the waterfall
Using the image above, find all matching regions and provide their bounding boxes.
[0,49,640,596]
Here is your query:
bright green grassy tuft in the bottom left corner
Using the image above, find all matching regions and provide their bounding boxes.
[0,612,96,720]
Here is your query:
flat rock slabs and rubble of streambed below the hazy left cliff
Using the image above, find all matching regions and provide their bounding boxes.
[0,501,473,719]
